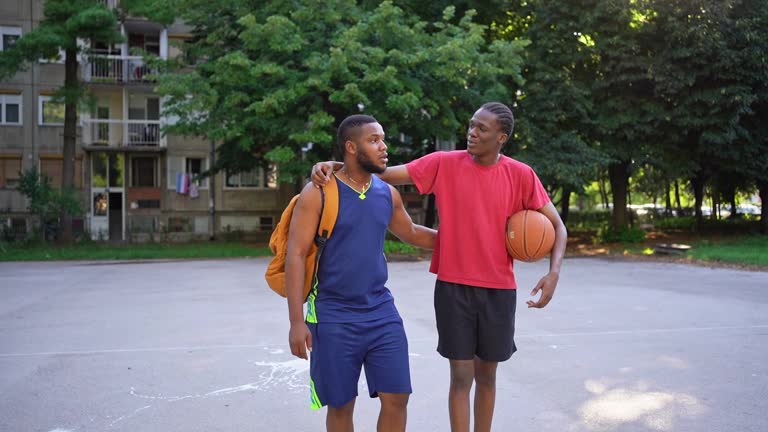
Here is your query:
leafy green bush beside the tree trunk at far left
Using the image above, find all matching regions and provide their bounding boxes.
[18,168,82,238]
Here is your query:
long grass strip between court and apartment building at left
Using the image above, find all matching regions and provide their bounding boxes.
[0,242,272,261]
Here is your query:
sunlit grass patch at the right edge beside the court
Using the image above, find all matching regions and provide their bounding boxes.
[688,236,768,267]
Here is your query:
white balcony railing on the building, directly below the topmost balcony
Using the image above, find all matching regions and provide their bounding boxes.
[83,119,165,147]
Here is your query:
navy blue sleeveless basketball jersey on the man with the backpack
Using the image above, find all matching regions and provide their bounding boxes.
[307,176,397,323]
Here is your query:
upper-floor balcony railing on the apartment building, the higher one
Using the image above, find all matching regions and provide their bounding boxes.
[84,55,155,83]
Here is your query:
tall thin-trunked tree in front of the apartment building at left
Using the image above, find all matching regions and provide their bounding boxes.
[0,0,121,242]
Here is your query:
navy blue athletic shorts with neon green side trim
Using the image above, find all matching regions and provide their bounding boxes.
[307,315,411,409]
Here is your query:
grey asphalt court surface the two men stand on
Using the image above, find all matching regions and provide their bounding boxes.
[0,259,768,432]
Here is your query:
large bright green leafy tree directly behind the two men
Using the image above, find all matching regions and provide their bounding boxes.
[153,0,525,181]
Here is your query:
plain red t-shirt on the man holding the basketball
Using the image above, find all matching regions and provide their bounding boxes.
[406,150,550,289]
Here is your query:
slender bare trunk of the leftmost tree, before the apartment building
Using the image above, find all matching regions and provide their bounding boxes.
[60,48,79,244]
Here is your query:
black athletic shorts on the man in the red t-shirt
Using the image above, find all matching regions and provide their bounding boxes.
[435,280,517,362]
